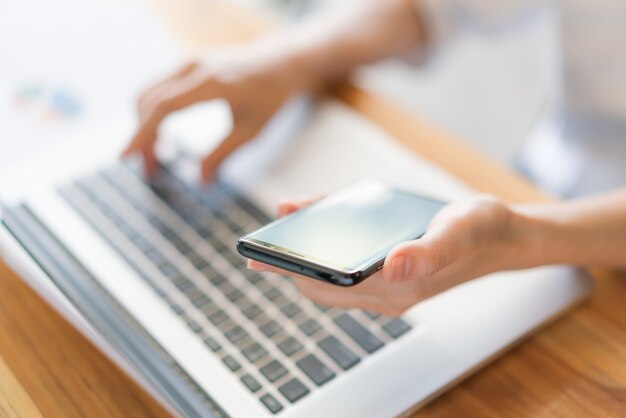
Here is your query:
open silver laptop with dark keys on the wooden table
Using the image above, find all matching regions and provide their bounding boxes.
[0,101,592,417]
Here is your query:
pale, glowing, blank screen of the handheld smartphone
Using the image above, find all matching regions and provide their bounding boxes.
[246,180,444,271]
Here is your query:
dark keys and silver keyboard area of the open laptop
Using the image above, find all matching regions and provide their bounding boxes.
[60,164,411,414]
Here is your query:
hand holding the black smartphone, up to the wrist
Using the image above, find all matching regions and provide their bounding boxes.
[248,196,524,316]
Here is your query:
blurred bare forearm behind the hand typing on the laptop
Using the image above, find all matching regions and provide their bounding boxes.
[241,0,426,90]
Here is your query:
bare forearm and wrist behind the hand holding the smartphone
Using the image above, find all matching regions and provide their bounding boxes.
[513,189,626,270]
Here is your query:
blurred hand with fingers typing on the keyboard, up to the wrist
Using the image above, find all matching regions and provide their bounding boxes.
[123,45,302,181]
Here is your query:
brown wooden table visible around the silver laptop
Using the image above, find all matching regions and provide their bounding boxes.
[0,0,626,418]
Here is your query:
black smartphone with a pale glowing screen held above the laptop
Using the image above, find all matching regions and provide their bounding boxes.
[237,180,445,286]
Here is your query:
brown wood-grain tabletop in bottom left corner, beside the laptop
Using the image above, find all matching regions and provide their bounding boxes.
[0,263,168,418]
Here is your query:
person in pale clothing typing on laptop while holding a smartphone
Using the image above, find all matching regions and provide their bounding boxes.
[126,0,626,315]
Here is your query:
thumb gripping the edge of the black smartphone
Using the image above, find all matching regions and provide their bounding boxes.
[382,236,455,282]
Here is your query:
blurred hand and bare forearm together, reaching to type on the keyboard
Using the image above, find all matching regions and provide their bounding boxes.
[124,1,425,186]
